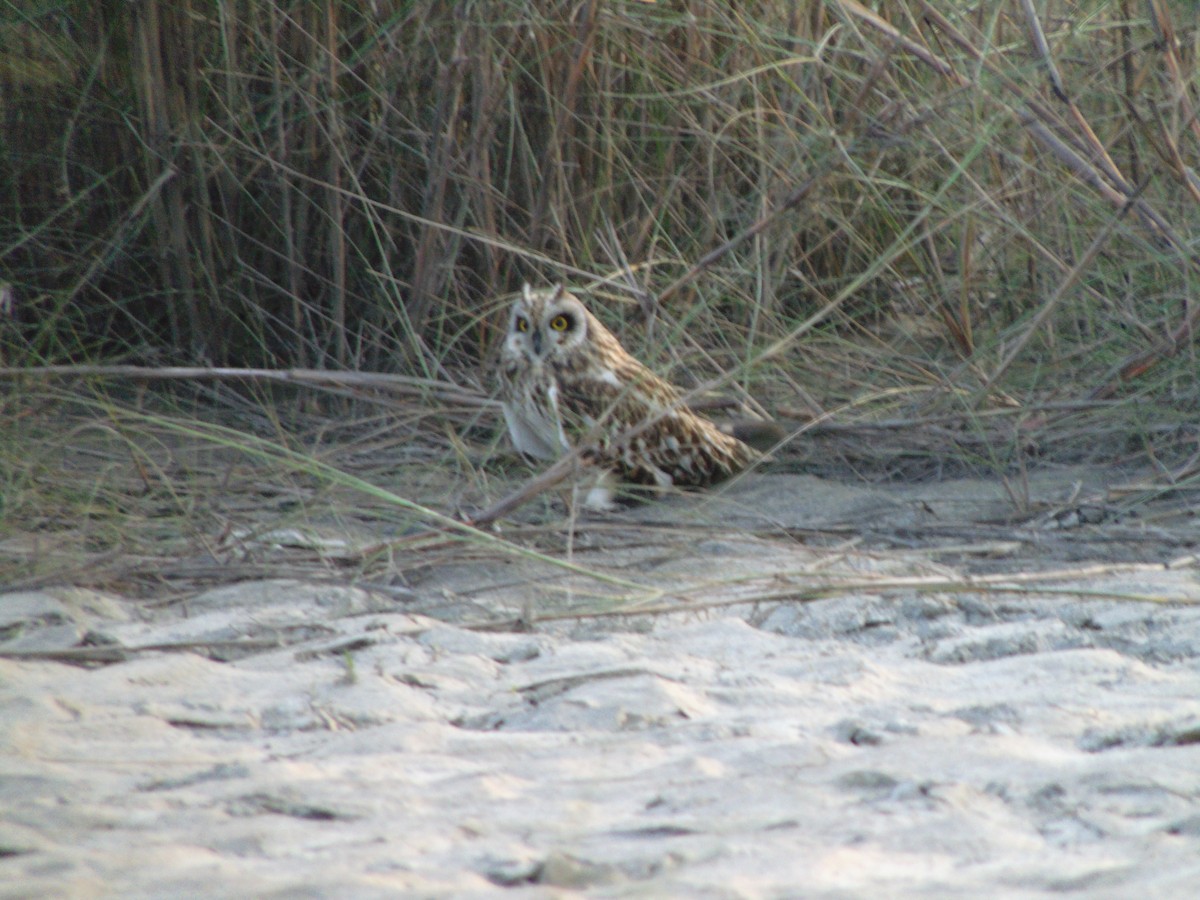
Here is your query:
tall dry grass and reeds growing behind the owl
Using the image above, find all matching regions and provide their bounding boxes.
[0,0,1200,595]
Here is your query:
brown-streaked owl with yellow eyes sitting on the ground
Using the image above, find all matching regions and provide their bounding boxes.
[497,284,760,510]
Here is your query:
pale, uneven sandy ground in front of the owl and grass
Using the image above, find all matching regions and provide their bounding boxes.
[0,472,1200,898]
